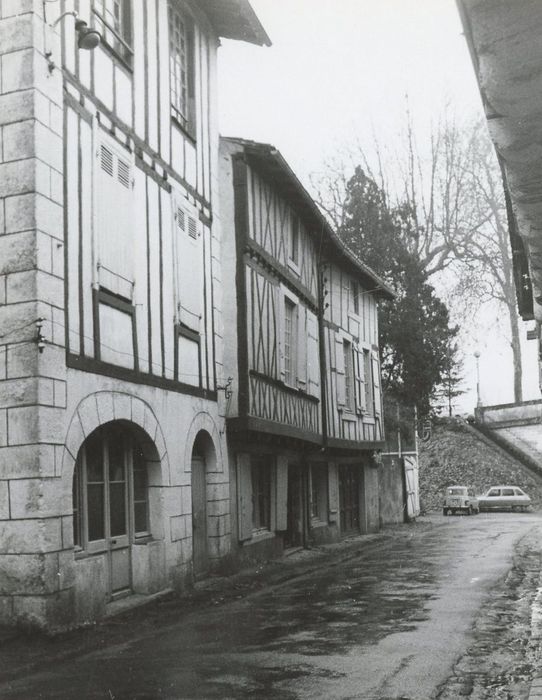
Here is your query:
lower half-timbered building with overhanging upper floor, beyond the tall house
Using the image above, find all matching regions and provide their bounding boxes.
[220,139,396,558]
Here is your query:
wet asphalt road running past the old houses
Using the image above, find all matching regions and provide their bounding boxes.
[0,513,542,700]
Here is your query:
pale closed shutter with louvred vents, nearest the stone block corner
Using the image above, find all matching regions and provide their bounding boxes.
[95,136,134,300]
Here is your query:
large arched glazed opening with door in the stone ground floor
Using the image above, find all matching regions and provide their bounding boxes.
[73,421,155,599]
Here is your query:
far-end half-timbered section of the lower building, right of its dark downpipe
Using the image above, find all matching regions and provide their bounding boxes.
[320,240,390,533]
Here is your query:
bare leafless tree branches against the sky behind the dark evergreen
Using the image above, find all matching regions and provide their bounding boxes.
[312,108,522,402]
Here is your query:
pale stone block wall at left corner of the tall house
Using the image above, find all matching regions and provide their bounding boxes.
[0,0,72,625]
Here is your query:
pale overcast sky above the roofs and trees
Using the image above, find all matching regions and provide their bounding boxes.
[218,0,539,412]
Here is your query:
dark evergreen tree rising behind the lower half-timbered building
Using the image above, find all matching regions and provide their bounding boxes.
[339,167,459,418]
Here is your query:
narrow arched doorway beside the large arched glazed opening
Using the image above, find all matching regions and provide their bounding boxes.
[191,430,216,578]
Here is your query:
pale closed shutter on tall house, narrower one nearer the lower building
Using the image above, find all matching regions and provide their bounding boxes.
[173,198,205,333]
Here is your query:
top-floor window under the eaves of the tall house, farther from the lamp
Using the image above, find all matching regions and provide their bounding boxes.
[169,1,196,137]
